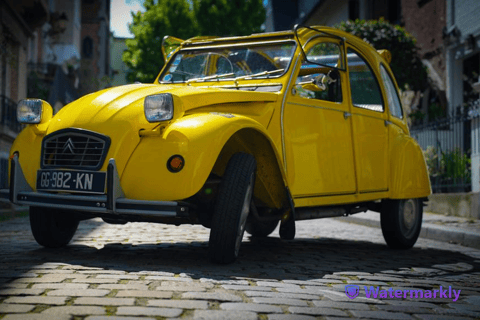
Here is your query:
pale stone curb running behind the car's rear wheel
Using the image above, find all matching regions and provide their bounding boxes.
[336,216,480,249]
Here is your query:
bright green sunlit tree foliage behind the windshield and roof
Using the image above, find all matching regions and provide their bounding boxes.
[122,0,265,82]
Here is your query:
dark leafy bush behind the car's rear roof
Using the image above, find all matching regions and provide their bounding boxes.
[336,19,427,91]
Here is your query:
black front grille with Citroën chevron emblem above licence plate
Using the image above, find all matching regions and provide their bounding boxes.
[41,129,110,170]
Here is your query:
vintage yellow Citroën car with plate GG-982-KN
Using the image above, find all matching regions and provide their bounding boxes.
[0,26,431,263]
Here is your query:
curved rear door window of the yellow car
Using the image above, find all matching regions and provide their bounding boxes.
[347,48,384,112]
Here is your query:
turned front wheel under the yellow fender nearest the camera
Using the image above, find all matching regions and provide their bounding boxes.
[209,153,256,263]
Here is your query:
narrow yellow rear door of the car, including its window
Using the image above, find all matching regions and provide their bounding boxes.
[347,47,389,193]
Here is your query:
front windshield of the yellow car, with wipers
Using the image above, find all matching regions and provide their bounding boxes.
[159,41,295,83]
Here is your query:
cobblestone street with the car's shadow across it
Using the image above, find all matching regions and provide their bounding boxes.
[0,214,480,320]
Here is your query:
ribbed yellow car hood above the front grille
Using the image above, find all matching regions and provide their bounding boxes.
[48,84,278,133]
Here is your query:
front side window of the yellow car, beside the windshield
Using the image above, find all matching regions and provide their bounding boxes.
[295,42,342,102]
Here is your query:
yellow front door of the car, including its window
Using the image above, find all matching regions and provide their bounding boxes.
[283,38,356,198]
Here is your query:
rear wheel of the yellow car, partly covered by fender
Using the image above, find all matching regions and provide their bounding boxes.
[380,199,423,249]
